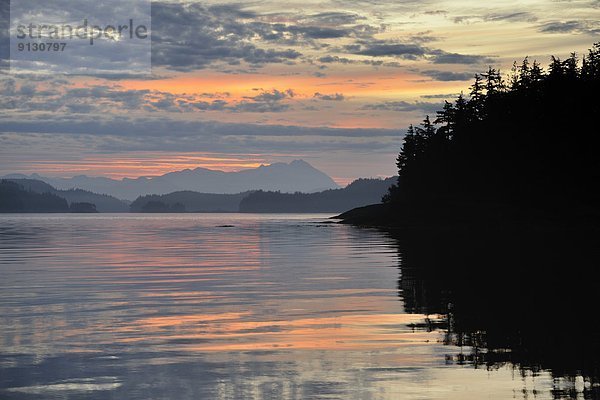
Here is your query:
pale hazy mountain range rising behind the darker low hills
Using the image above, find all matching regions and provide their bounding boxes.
[2,160,339,200]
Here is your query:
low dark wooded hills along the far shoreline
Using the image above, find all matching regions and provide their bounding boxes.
[0,178,396,213]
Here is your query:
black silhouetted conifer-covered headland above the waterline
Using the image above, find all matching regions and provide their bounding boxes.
[383,43,600,223]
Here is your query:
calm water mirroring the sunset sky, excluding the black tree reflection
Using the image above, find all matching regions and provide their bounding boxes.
[0,214,590,400]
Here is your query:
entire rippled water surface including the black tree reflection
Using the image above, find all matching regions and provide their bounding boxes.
[0,214,599,399]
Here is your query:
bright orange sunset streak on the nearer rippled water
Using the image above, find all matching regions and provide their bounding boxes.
[121,312,439,352]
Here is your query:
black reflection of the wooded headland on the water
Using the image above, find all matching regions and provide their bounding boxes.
[397,228,600,399]
